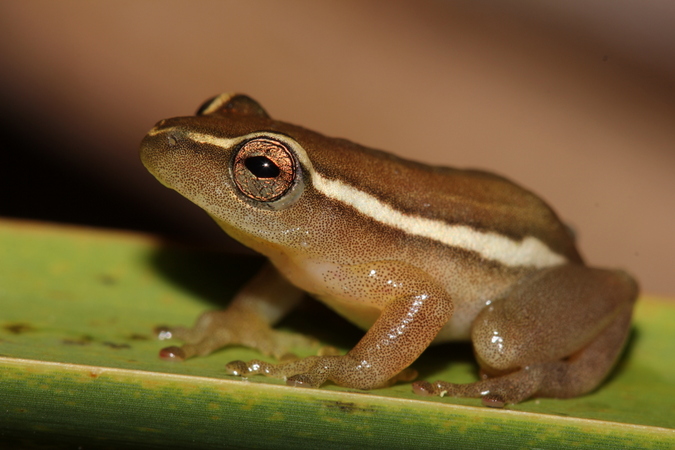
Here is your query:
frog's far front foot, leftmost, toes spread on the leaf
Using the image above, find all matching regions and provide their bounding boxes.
[156,308,316,361]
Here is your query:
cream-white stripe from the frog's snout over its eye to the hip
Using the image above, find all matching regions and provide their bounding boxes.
[182,133,567,267]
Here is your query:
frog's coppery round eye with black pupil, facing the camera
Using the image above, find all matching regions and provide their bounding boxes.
[232,138,296,202]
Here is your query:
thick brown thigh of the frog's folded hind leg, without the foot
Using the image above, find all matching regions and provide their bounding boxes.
[471,265,637,375]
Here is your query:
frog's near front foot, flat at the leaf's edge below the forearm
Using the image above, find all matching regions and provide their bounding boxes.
[225,355,417,389]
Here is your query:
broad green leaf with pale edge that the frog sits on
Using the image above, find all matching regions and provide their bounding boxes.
[0,221,675,449]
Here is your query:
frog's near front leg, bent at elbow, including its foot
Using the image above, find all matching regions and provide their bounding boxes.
[228,261,453,389]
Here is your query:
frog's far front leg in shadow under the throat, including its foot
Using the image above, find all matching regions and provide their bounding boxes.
[158,263,314,361]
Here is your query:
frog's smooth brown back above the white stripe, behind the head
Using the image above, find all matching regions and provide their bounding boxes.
[284,125,581,262]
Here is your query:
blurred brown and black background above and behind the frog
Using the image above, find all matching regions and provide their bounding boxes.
[0,0,675,296]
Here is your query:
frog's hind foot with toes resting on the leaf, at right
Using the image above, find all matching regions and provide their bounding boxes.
[413,367,543,408]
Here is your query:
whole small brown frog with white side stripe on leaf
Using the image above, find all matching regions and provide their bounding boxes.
[140,94,639,408]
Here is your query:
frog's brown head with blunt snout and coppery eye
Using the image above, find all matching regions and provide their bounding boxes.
[140,94,320,251]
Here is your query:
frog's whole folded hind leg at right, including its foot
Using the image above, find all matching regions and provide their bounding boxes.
[413,266,637,407]
